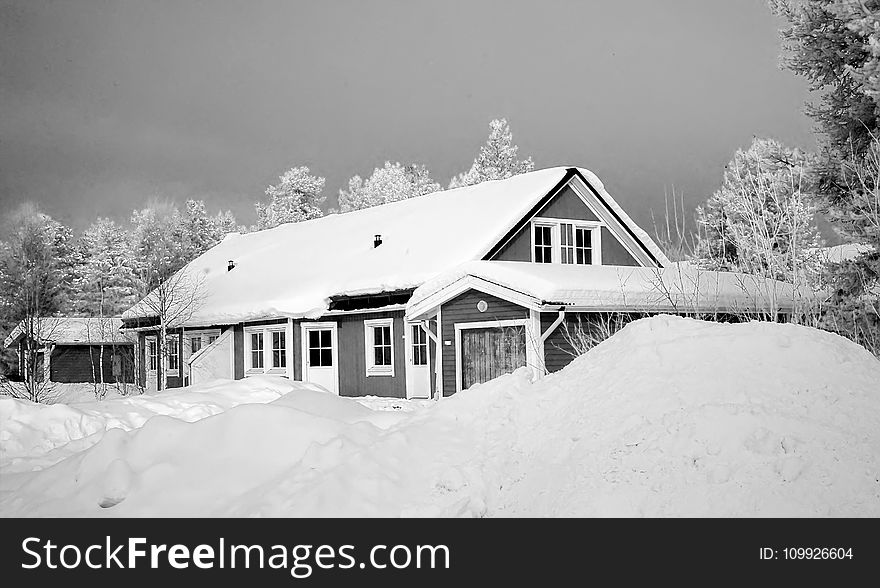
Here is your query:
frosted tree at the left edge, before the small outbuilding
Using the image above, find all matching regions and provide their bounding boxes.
[0,204,74,402]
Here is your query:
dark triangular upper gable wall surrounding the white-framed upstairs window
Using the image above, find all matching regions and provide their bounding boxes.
[492,187,639,266]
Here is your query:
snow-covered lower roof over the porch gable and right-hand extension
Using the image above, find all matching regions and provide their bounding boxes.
[406,261,801,319]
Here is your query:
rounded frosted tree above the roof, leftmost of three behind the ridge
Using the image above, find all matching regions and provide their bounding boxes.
[256,166,325,231]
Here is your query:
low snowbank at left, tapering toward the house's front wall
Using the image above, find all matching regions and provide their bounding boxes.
[0,377,317,471]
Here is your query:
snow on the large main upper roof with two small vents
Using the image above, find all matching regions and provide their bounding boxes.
[123,167,667,326]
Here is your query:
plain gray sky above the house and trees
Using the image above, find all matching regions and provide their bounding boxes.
[0,0,814,232]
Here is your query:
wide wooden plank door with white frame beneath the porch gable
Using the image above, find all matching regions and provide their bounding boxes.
[460,325,526,390]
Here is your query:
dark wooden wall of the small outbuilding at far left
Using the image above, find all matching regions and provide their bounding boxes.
[49,345,134,384]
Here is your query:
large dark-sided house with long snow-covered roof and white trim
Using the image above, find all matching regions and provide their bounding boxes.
[123,167,794,398]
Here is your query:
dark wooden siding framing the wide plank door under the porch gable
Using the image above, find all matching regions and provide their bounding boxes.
[440,290,529,396]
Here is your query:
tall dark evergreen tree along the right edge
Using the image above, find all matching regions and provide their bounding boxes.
[770,0,880,355]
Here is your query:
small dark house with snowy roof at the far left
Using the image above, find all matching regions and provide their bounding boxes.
[3,317,135,384]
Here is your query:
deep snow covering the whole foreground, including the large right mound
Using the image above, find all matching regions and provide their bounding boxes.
[0,316,880,517]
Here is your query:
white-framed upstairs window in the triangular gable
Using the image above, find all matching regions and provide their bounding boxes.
[532,218,602,265]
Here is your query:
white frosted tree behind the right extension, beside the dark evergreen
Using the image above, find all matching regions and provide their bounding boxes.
[696,139,819,282]
